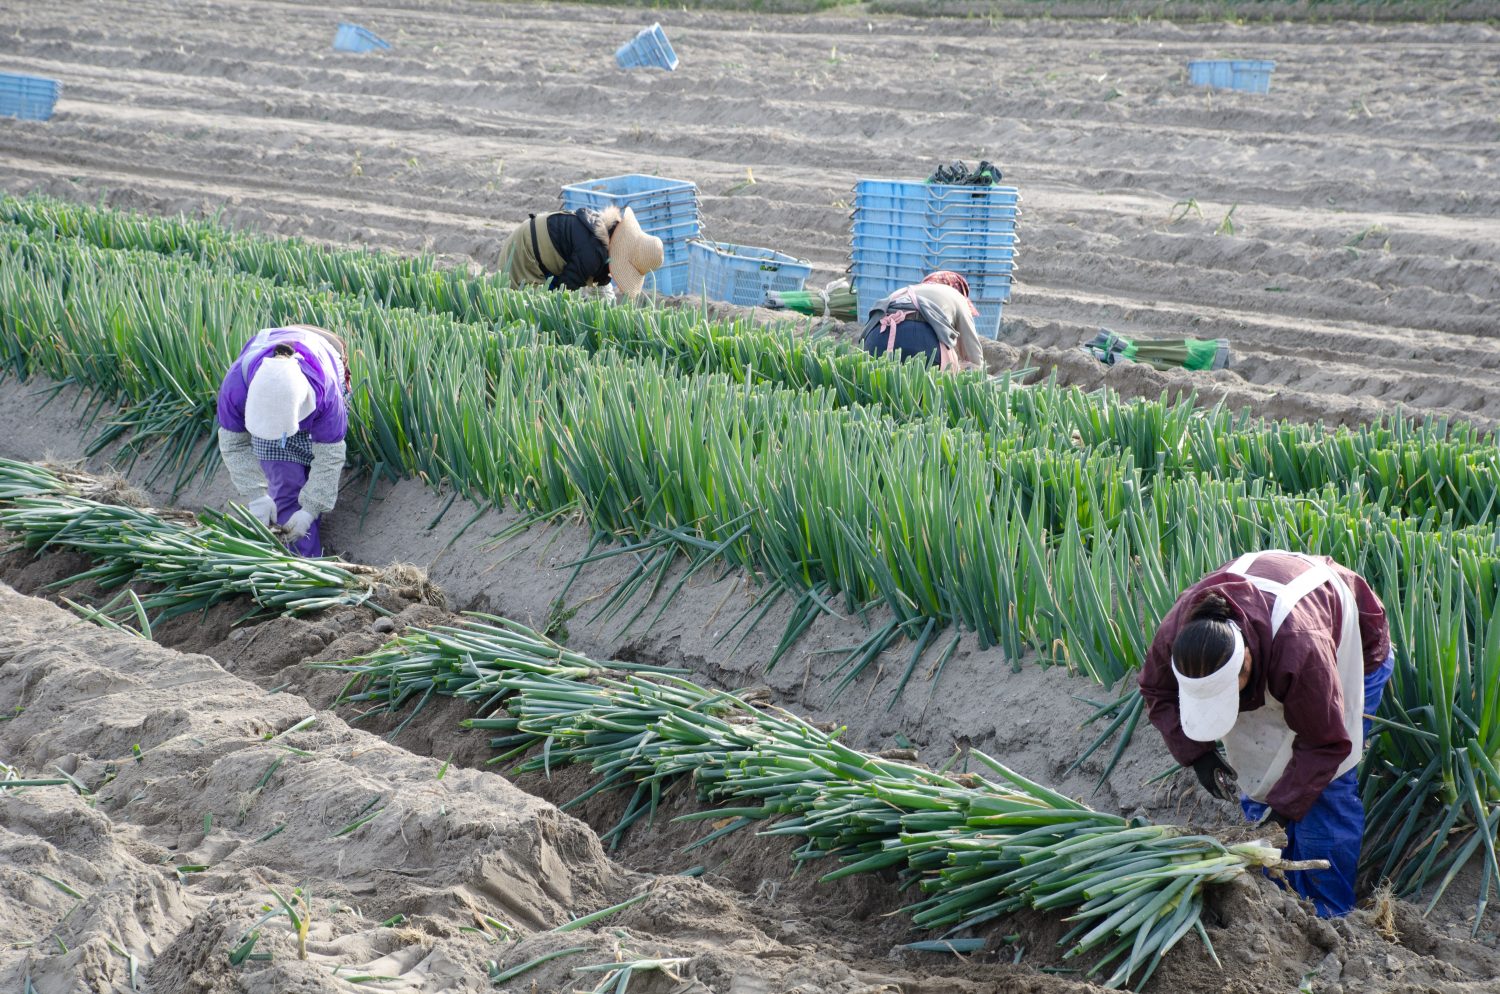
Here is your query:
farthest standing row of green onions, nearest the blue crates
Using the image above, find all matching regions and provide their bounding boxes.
[0,189,1500,525]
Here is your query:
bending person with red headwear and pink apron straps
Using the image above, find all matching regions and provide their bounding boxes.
[861,270,984,370]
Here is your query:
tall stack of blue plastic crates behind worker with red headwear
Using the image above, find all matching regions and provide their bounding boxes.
[849,180,1020,339]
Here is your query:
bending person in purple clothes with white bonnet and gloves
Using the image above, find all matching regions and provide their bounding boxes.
[219,324,350,556]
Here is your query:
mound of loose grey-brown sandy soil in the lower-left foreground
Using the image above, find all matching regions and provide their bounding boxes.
[0,585,1080,994]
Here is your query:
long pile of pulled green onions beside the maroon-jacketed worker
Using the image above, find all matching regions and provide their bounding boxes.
[329,619,1320,987]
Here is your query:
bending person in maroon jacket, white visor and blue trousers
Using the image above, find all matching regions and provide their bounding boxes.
[1140,550,1395,918]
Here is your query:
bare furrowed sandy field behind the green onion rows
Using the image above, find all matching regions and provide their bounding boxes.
[0,0,1500,424]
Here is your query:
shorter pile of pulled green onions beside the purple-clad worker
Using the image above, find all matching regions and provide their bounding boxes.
[0,459,431,622]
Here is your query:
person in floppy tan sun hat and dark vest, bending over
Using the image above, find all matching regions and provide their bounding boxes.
[500,207,663,298]
